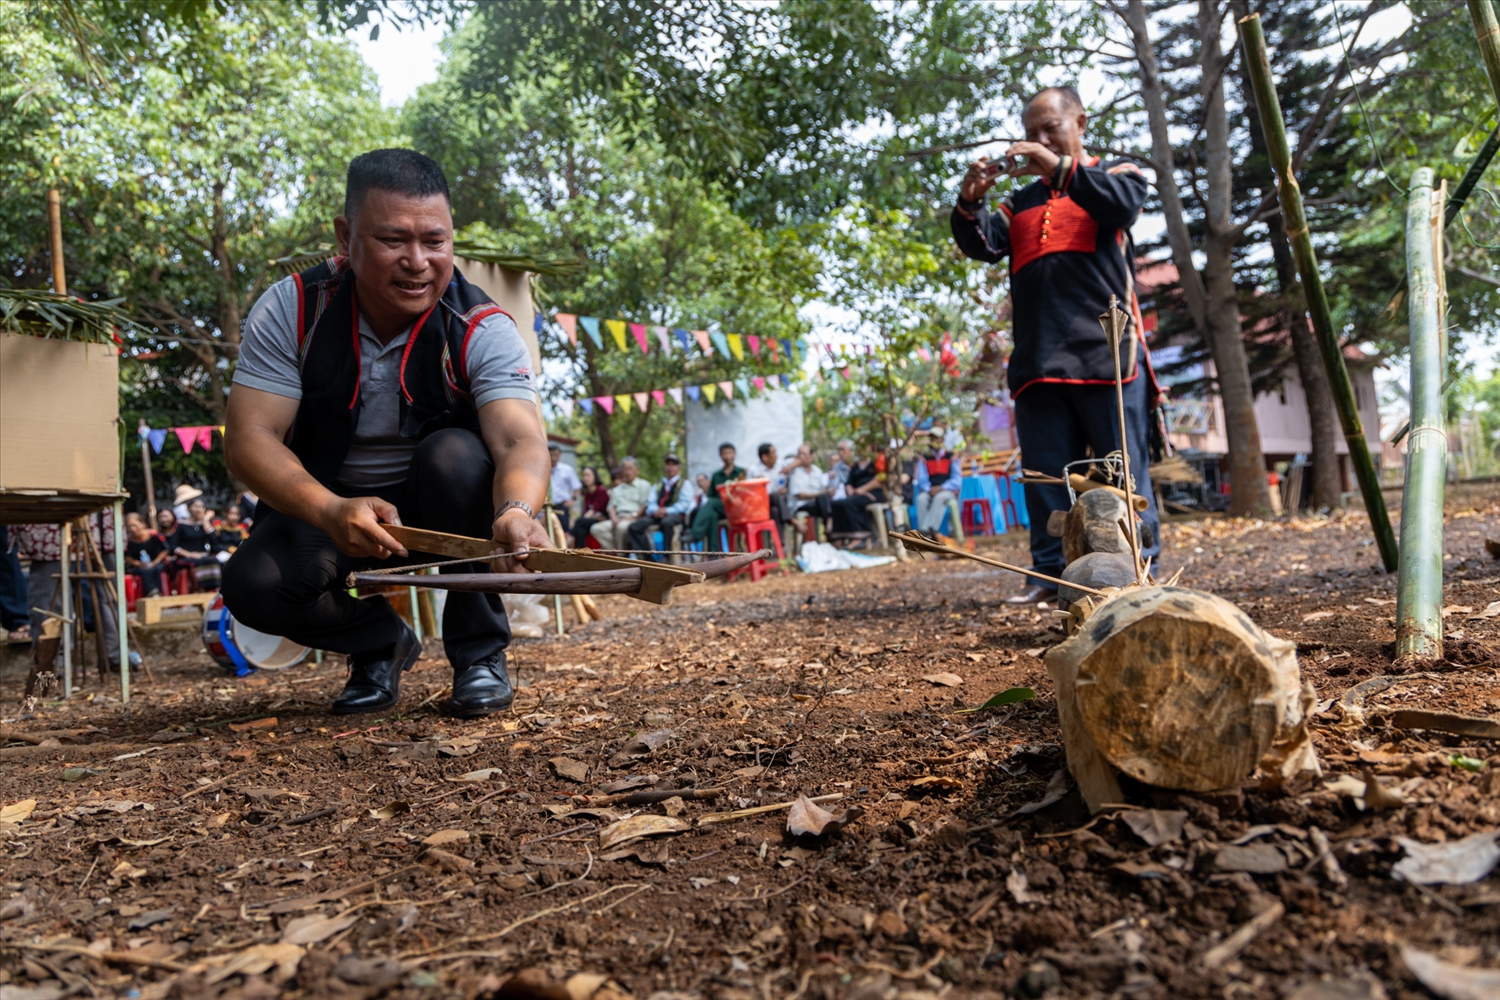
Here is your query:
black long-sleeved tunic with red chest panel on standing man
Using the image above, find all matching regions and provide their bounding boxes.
[953,156,1155,396]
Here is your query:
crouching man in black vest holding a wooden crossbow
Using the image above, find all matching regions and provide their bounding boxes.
[224,150,549,717]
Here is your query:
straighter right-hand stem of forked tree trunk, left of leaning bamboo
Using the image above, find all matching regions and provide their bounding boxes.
[1199,0,1271,514]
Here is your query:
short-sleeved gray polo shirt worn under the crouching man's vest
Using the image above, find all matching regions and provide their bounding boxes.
[234,277,537,490]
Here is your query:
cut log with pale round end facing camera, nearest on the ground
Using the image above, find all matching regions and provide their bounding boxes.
[1047,586,1317,811]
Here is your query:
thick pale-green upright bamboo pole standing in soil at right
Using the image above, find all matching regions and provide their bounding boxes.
[1397,166,1448,661]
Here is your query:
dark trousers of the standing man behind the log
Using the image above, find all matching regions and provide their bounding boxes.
[1016,375,1161,576]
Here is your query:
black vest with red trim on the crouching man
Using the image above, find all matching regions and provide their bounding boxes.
[288,256,509,486]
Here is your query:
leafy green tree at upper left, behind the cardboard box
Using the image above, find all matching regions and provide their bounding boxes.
[0,3,395,509]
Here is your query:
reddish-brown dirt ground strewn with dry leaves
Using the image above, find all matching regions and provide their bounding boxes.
[0,486,1500,1000]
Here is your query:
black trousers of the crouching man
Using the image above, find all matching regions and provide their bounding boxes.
[222,427,510,673]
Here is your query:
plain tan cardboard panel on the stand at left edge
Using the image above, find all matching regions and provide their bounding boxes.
[0,333,120,493]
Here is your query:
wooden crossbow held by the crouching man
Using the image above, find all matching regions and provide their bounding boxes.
[348,525,773,604]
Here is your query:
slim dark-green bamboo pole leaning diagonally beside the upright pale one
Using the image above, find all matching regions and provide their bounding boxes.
[1239,13,1400,573]
